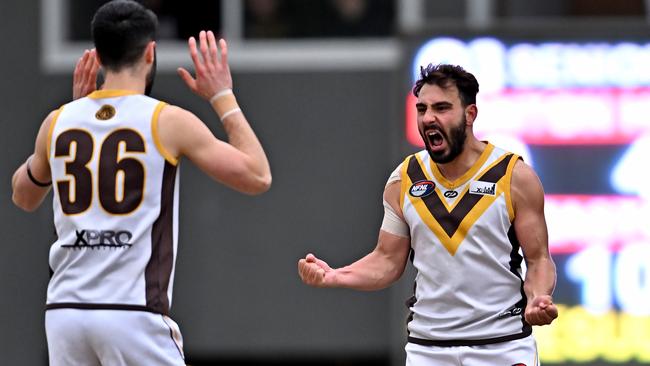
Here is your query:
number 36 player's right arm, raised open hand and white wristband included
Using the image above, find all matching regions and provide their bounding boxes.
[166,31,271,194]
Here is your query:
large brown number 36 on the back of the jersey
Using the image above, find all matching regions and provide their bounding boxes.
[54,129,145,215]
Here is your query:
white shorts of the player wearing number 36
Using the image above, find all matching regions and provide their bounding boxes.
[45,309,185,366]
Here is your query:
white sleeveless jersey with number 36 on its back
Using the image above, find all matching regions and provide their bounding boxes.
[46,90,178,314]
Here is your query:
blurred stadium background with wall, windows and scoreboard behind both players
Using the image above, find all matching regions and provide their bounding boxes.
[0,0,650,366]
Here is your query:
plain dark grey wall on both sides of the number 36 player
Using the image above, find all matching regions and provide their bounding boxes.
[0,0,409,365]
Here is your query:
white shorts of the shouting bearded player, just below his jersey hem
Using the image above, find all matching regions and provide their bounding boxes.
[405,335,539,366]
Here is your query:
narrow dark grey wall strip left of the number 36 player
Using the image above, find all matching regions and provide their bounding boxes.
[0,1,52,365]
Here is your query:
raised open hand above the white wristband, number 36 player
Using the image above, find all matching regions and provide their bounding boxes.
[177,31,232,100]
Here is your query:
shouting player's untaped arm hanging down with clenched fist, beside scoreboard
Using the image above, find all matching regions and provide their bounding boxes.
[512,161,558,325]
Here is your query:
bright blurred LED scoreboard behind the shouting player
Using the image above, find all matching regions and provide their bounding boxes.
[405,37,650,365]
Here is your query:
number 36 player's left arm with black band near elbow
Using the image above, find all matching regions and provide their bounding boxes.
[11,111,56,212]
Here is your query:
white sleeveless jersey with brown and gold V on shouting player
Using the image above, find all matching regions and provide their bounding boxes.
[400,144,531,346]
